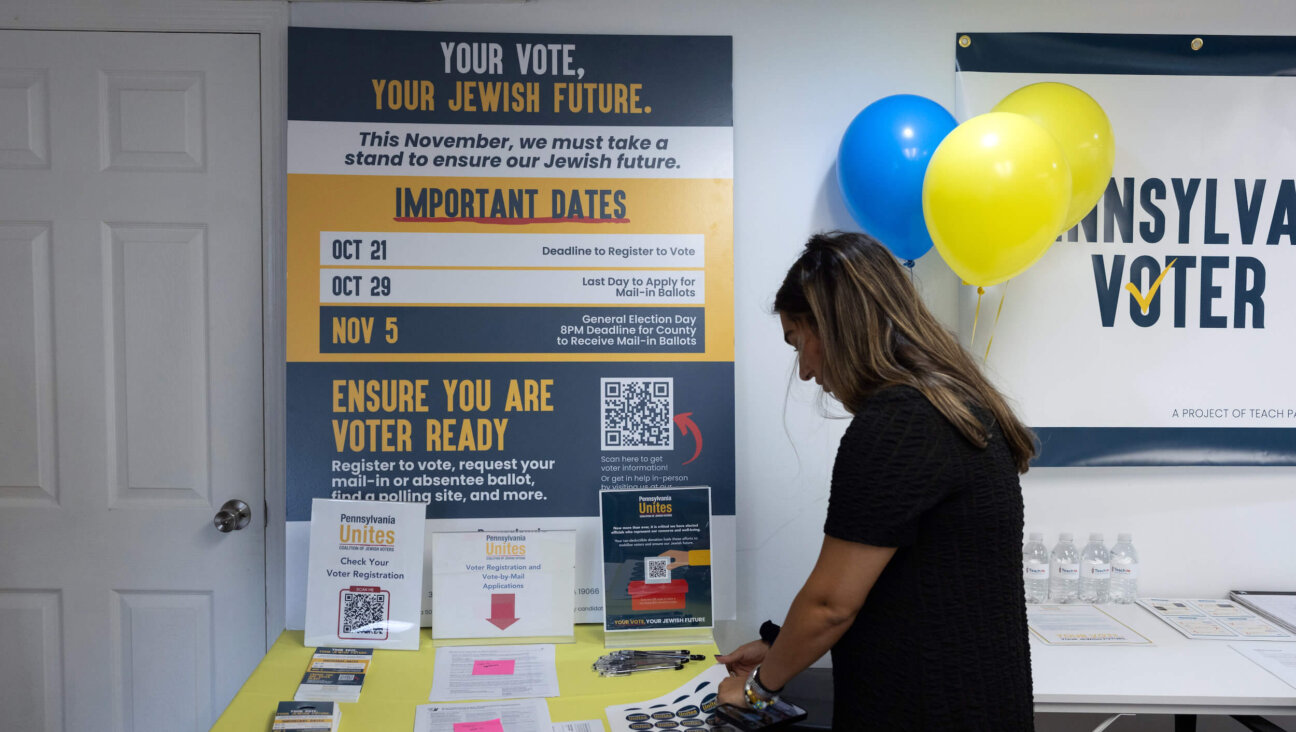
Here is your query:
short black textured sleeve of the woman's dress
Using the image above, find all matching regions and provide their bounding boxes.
[824,386,958,547]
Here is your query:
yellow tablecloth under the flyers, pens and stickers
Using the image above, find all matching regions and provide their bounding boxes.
[213,624,719,732]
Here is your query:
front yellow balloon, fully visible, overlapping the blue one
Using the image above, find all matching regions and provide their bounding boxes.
[923,111,1070,286]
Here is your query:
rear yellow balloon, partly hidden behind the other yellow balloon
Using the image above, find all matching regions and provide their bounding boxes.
[993,82,1116,229]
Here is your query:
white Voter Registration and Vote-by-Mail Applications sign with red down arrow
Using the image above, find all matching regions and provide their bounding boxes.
[432,531,575,637]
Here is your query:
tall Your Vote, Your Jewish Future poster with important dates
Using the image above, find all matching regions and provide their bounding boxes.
[286,27,734,627]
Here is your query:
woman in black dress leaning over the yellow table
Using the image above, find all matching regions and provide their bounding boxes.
[719,233,1034,732]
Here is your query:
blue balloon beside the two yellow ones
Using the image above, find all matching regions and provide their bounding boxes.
[837,95,958,260]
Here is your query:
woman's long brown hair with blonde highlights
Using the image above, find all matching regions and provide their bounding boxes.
[774,232,1036,473]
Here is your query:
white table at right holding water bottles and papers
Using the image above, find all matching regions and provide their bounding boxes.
[1030,605,1296,729]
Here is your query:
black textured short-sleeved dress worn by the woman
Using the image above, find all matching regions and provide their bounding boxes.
[824,386,1034,732]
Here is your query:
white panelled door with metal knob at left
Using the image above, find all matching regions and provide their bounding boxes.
[0,31,266,732]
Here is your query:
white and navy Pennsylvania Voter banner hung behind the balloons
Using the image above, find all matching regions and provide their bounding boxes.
[956,34,1296,466]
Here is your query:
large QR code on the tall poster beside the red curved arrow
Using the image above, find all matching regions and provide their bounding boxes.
[600,377,675,450]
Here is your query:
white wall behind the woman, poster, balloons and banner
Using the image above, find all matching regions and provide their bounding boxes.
[293,0,1296,729]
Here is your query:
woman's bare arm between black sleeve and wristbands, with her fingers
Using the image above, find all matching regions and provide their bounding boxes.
[721,536,896,706]
